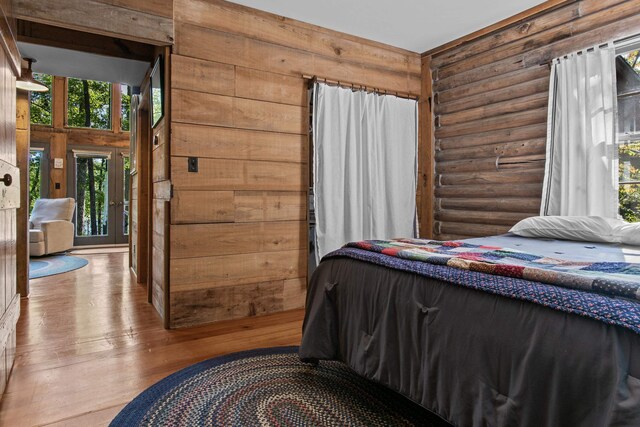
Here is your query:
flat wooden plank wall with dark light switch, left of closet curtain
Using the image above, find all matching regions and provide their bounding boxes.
[170,0,420,327]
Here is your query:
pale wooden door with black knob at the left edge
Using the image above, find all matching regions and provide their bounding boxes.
[0,0,20,395]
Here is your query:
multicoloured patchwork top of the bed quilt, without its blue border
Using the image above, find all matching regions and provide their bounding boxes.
[345,239,640,301]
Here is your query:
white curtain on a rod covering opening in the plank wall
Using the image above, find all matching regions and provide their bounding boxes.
[313,83,418,260]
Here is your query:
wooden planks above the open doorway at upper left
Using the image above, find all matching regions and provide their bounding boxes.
[12,0,173,46]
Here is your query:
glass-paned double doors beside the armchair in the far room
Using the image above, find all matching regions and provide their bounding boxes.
[67,146,131,246]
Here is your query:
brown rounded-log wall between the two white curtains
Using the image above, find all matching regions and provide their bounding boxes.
[423,0,640,239]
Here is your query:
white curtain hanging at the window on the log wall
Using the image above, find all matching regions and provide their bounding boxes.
[540,47,618,218]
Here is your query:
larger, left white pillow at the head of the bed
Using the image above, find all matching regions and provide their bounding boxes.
[509,216,623,243]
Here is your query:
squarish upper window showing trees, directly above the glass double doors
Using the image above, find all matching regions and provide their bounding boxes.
[67,78,111,129]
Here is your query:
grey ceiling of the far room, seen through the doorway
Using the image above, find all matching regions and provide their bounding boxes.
[18,42,151,86]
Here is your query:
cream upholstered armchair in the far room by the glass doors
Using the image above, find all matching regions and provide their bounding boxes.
[29,197,76,256]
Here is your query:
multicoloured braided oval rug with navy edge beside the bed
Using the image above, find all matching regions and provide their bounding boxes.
[111,347,446,427]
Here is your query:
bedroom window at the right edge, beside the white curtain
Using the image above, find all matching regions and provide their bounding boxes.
[616,49,640,222]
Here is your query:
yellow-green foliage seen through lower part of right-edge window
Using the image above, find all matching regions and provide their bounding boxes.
[618,142,640,222]
